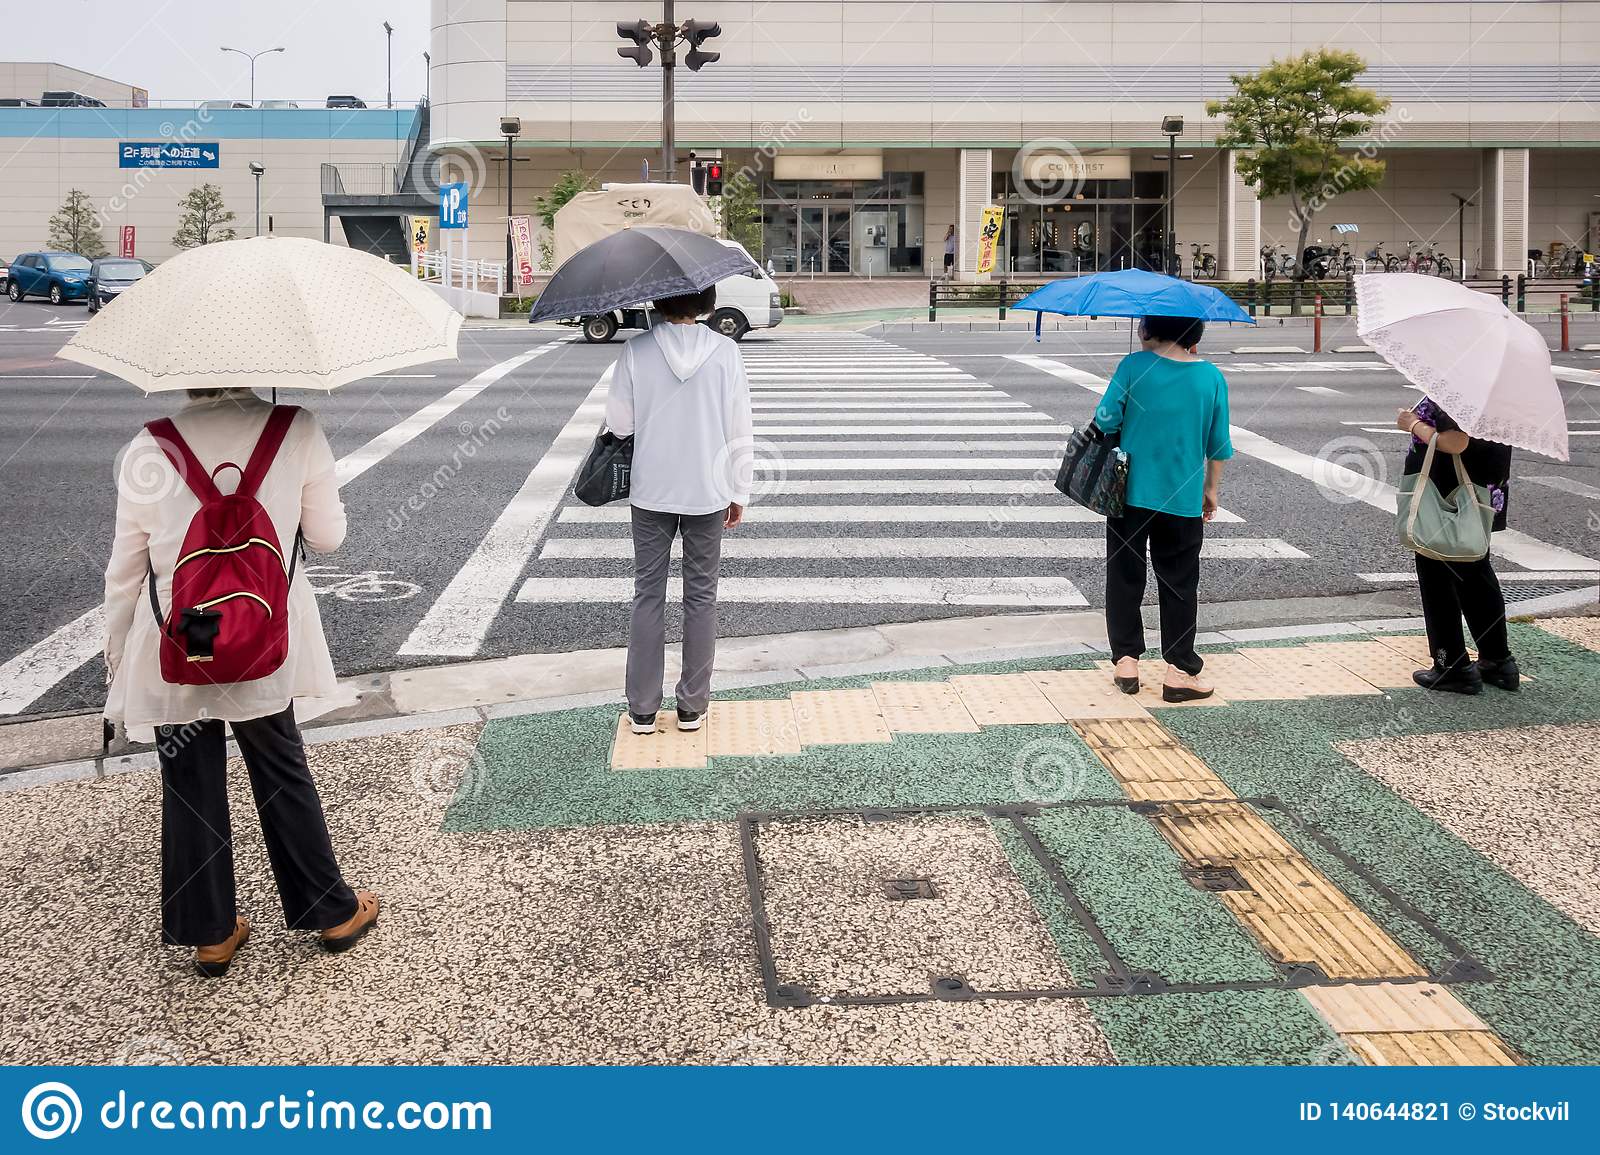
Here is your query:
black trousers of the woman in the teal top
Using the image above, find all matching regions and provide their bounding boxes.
[1106,506,1205,673]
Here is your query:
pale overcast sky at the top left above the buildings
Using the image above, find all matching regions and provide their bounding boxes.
[9,0,429,106]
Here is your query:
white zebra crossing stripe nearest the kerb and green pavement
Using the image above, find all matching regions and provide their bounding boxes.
[517,574,1088,606]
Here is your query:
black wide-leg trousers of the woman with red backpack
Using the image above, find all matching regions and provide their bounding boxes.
[155,705,355,947]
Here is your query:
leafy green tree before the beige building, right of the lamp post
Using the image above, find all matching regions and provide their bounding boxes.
[1206,48,1389,277]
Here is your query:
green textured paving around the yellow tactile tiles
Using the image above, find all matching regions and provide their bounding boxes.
[445,625,1600,1064]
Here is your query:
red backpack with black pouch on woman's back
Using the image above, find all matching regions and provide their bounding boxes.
[146,405,299,686]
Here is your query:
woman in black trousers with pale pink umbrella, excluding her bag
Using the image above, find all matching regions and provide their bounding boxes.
[1355,274,1568,694]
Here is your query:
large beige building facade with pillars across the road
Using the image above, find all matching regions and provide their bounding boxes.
[430,0,1600,277]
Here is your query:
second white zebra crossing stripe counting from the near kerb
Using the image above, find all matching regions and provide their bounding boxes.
[539,537,1310,562]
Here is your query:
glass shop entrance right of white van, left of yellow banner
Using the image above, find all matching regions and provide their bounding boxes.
[762,173,925,277]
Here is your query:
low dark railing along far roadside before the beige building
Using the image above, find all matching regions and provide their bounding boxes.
[928,275,1600,322]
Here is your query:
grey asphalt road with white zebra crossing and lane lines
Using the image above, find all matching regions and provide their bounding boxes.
[9,292,1600,713]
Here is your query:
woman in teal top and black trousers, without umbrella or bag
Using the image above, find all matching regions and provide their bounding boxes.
[1094,317,1234,702]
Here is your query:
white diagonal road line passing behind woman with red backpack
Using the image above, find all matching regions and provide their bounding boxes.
[0,342,562,715]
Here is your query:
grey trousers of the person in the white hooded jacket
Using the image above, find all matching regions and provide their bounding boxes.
[627,506,723,713]
